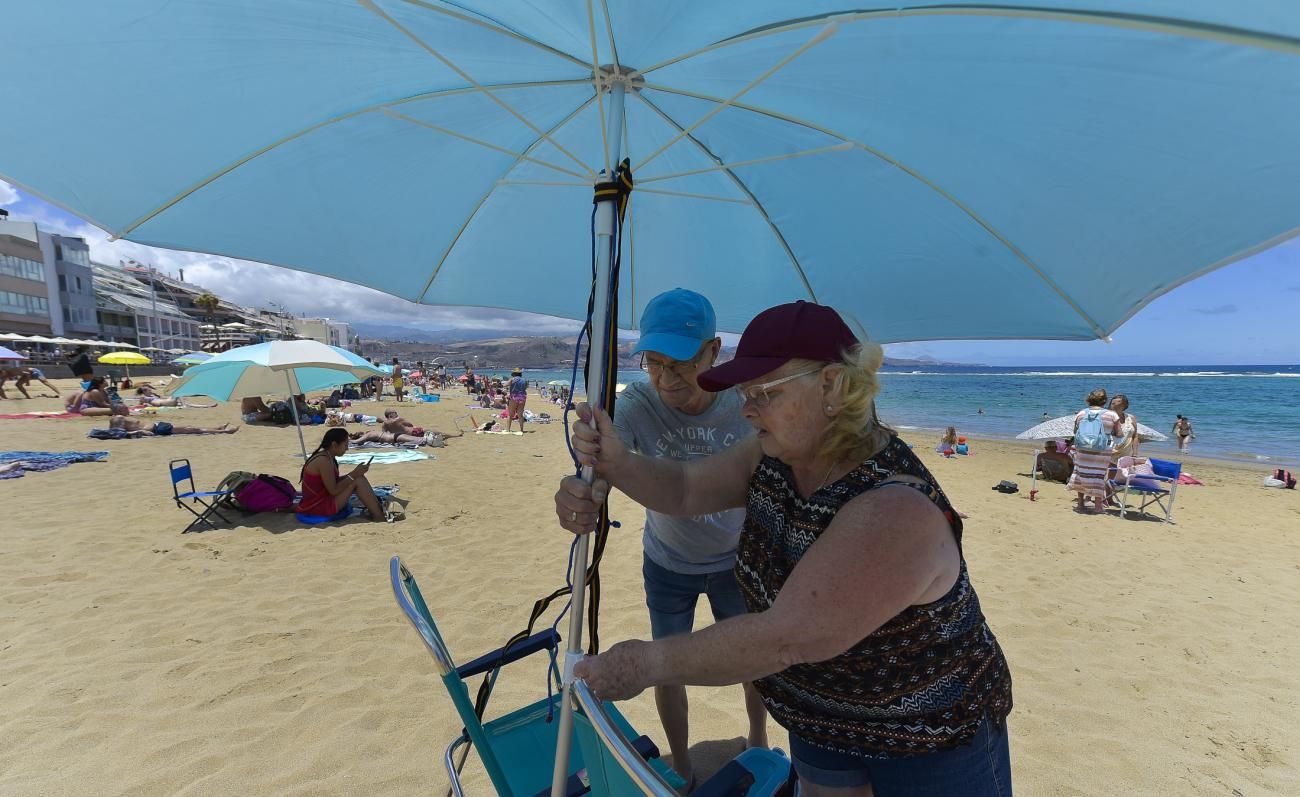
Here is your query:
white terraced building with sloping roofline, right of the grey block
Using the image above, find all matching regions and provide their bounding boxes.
[91,263,202,351]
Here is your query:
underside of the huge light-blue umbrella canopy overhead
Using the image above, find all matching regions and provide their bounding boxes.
[0,0,1300,342]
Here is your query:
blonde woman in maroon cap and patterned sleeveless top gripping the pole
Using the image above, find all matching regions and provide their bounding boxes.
[556,302,1011,797]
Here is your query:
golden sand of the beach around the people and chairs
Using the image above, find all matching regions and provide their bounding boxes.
[0,380,1300,796]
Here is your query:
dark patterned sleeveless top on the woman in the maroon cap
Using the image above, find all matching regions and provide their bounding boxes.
[736,437,1011,758]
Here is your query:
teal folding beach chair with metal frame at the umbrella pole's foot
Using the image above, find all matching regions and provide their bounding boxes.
[389,556,683,797]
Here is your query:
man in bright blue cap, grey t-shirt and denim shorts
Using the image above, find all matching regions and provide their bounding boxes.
[556,287,767,784]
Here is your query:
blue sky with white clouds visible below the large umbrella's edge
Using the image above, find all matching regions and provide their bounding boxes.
[0,181,1300,365]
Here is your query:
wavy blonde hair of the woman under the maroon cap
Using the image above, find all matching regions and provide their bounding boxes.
[796,341,893,463]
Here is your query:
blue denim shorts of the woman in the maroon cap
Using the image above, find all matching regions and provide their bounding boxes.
[790,720,1011,797]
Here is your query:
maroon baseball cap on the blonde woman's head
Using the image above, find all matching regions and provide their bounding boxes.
[698,299,858,393]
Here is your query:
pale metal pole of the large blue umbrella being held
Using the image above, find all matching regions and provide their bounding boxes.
[551,83,624,797]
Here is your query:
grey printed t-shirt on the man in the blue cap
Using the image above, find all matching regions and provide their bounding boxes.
[614,382,754,573]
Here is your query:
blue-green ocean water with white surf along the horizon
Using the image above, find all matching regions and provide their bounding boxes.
[473,365,1300,465]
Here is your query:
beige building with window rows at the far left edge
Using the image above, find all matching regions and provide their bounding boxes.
[0,220,57,335]
